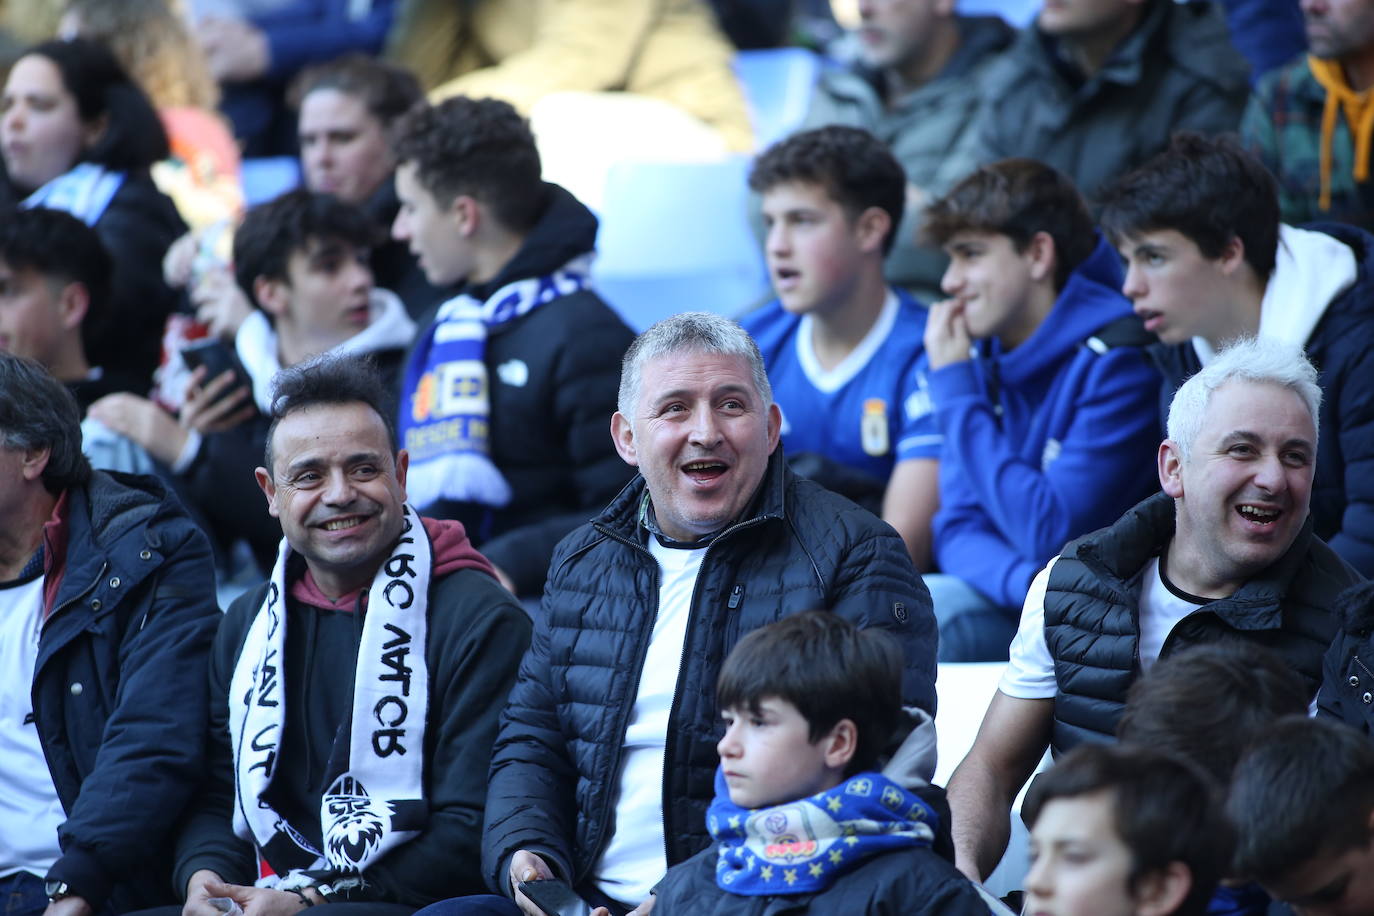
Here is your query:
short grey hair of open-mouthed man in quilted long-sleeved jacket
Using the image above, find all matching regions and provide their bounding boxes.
[616,312,772,419]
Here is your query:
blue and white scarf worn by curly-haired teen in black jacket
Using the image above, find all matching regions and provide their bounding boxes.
[400,253,592,509]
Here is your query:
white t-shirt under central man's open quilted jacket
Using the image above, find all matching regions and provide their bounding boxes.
[594,537,706,904]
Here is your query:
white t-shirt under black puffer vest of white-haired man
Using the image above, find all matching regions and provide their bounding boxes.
[998,558,1205,699]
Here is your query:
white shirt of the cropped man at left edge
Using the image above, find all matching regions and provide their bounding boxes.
[0,575,66,878]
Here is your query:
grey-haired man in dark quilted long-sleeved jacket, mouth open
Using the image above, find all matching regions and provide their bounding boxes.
[434,313,936,913]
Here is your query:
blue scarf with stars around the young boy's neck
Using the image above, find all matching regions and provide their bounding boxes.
[706,769,938,897]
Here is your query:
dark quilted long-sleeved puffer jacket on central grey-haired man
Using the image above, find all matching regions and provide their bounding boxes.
[482,449,936,893]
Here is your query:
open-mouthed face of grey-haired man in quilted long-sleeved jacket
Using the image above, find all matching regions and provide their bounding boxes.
[611,350,782,541]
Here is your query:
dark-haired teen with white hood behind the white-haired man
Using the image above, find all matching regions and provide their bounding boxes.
[1102,135,1374,575]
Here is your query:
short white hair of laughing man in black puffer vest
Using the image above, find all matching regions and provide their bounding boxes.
[1168,338,1322,460]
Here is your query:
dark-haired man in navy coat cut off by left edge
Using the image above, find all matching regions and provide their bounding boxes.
[0,353,220,916]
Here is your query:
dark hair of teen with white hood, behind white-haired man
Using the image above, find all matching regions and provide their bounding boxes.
[1098,132,1279,280]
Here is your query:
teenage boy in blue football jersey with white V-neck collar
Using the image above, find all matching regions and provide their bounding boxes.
[741,126,940,570]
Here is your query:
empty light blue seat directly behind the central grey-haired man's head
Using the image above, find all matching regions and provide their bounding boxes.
[592,157,768,331]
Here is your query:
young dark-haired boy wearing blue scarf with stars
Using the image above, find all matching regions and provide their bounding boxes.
[653,611,988,916]
